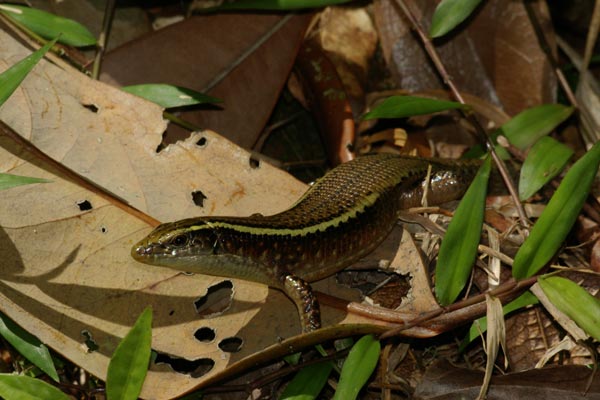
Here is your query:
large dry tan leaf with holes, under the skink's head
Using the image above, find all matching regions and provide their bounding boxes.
[0,32,372,398]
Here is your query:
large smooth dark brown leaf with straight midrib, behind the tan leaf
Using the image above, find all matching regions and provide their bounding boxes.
[101,13,310,148]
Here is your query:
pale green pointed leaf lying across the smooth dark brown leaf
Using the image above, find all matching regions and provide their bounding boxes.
[121,83,222,108]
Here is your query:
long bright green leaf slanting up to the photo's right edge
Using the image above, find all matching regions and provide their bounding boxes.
[513,142,600,279]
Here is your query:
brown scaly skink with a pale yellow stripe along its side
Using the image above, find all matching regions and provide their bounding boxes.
[131,154,480,332]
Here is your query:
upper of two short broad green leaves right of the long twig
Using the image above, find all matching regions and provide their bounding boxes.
[500,104,574,150]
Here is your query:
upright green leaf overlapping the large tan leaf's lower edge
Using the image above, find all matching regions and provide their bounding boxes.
[106,307,152,400]
